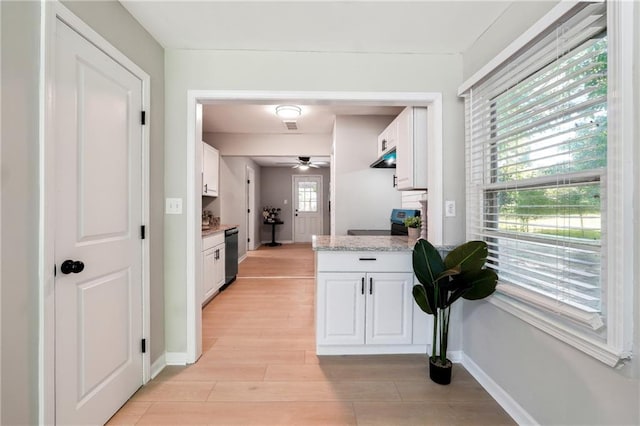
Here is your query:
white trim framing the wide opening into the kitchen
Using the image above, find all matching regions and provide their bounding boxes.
[185,89,444,363]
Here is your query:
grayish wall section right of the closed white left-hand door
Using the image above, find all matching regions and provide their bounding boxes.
[63,0,165,363]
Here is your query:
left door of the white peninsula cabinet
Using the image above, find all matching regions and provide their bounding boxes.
[316,273,365,345]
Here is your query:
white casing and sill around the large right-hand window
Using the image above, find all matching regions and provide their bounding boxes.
[458,1,640,367]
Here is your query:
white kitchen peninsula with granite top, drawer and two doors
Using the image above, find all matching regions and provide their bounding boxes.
[312,235,431,355]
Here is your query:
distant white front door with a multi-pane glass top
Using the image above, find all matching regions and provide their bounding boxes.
[293,175,322,243]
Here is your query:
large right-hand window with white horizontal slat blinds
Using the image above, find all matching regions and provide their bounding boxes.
[464,3,625,365]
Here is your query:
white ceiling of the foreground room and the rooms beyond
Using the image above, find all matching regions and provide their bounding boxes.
[120,0,511,166]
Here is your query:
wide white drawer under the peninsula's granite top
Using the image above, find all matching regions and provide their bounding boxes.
[316,251,413,272]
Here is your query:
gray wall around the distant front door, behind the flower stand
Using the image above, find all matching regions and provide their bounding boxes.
[258,167,331,242]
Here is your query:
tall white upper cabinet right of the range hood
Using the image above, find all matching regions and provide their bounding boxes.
[392,107,428,191]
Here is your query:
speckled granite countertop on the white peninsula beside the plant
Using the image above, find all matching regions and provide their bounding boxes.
[312,235,415,251]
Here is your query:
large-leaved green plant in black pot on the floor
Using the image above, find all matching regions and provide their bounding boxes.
[413,239,498,385]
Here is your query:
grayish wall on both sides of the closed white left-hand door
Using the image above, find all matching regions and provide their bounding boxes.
[0,1,164,424]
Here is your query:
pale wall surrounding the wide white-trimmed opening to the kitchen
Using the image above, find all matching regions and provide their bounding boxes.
[165,50,464,352]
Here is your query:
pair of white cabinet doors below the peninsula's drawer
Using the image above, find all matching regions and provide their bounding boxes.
[316,272,413,345]
